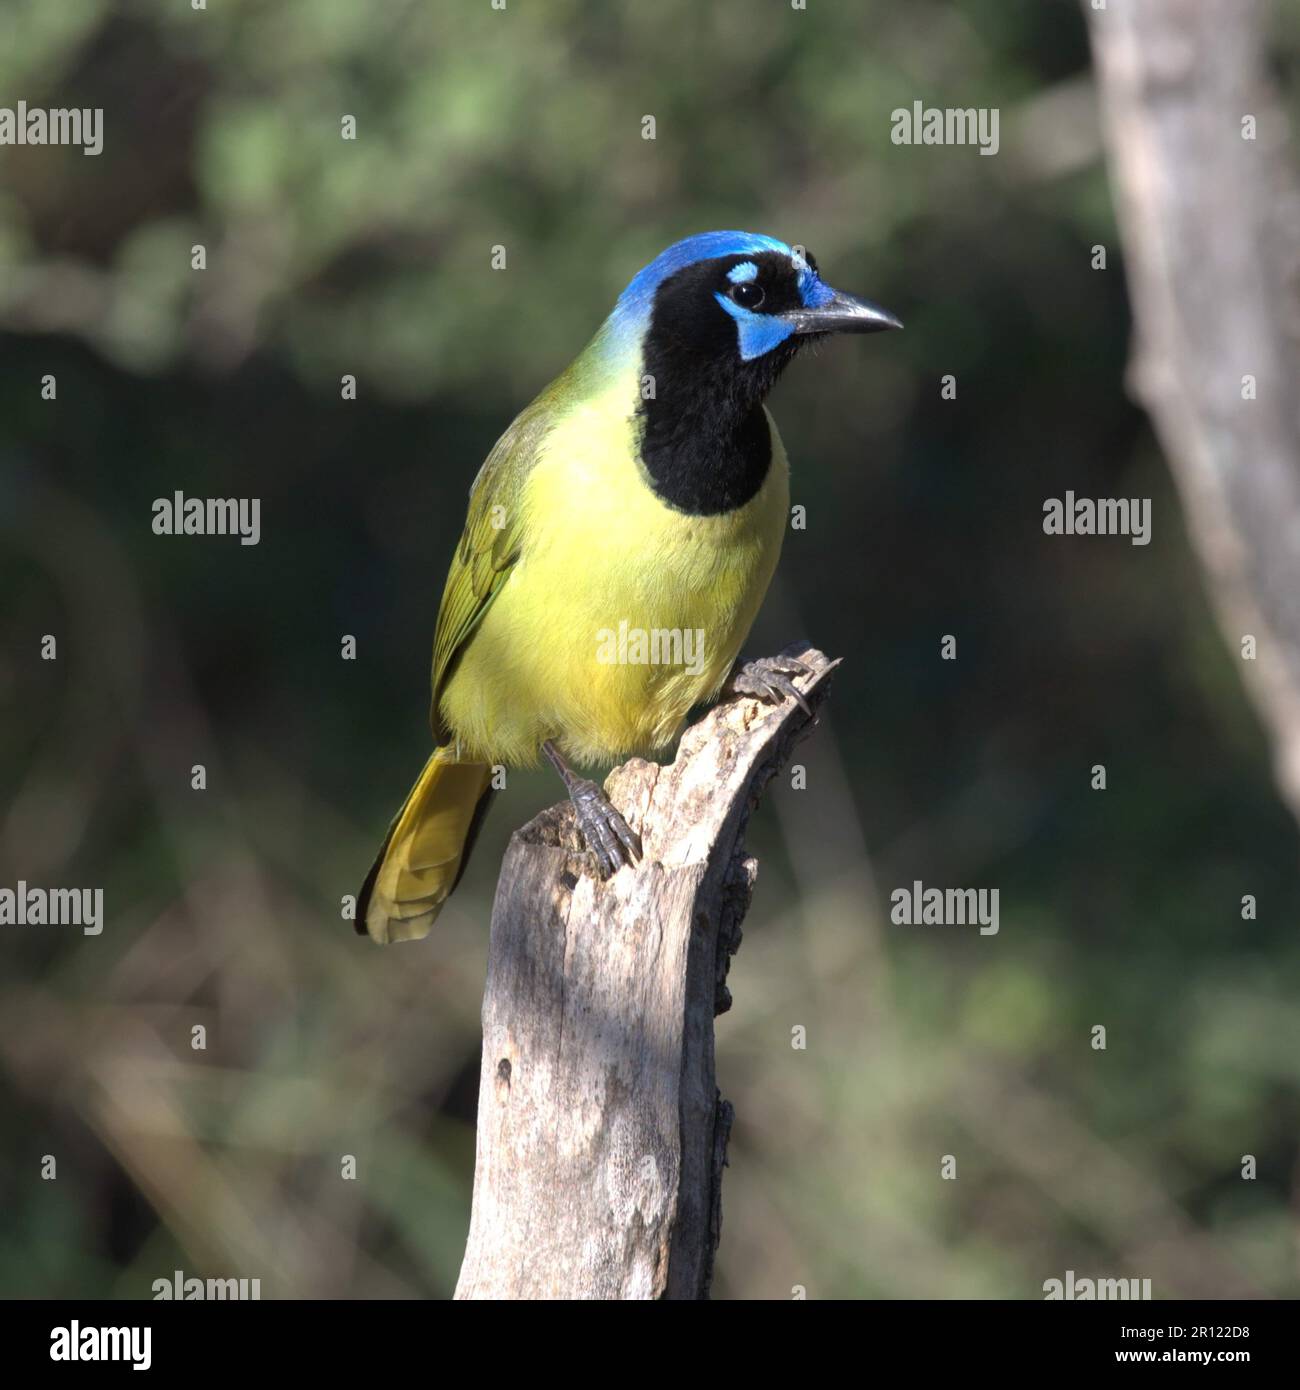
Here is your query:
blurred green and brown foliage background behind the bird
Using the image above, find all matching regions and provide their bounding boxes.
[0,0,1300,1297]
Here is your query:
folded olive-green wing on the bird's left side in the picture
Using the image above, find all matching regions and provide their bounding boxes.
[428,382,559,744]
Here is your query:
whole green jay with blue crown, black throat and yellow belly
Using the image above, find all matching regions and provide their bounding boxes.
[355,231,902,944]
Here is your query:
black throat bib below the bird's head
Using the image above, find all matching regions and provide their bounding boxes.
[637,341,780,516]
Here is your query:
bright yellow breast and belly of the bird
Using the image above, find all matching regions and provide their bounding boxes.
[442,374,790,765]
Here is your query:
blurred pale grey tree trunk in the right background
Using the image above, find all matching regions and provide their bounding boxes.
[1084,0,1300,819]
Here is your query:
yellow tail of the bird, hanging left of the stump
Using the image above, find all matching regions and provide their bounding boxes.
[356,748,492,942]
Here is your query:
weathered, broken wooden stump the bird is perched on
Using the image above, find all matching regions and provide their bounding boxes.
[456,644,837,1298]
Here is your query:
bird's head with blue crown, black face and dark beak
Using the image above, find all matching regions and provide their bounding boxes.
[612,232,902,399]
